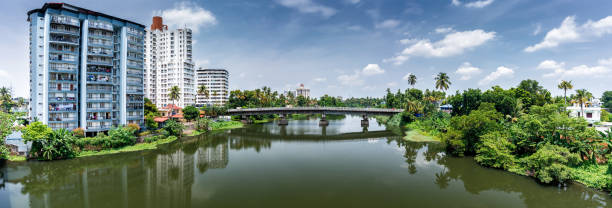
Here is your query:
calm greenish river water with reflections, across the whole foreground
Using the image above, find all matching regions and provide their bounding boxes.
[0,117,612,208]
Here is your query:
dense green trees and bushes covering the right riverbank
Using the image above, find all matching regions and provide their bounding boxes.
[377,80,612,192]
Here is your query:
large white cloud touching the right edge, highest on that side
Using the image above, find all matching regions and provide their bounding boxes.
[525,16,612,52]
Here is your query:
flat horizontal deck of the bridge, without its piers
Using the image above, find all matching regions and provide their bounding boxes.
[227,107,403,115]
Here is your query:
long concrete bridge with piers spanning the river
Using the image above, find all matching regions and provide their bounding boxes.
[226,107,404,126]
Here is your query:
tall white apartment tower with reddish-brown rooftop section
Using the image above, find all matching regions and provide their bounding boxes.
[144,17,196,107]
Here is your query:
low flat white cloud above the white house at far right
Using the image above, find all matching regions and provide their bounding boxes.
[537,58,612,78]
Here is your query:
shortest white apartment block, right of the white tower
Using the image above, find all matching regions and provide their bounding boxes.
[196,68,229,106]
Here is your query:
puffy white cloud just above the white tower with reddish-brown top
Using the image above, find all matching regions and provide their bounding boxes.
[155,2,217,33]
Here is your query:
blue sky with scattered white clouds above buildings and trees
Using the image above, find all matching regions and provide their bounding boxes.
[0,0,612,98]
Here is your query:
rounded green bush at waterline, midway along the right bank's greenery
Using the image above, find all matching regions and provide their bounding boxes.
[474,131,516,170]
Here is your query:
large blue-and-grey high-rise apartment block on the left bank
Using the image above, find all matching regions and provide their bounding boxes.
[28,3,145,133]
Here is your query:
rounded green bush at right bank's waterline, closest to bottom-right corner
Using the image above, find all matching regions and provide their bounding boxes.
[522,144,581,183]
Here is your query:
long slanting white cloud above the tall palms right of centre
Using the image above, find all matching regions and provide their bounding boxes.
[384,29,495,65]
